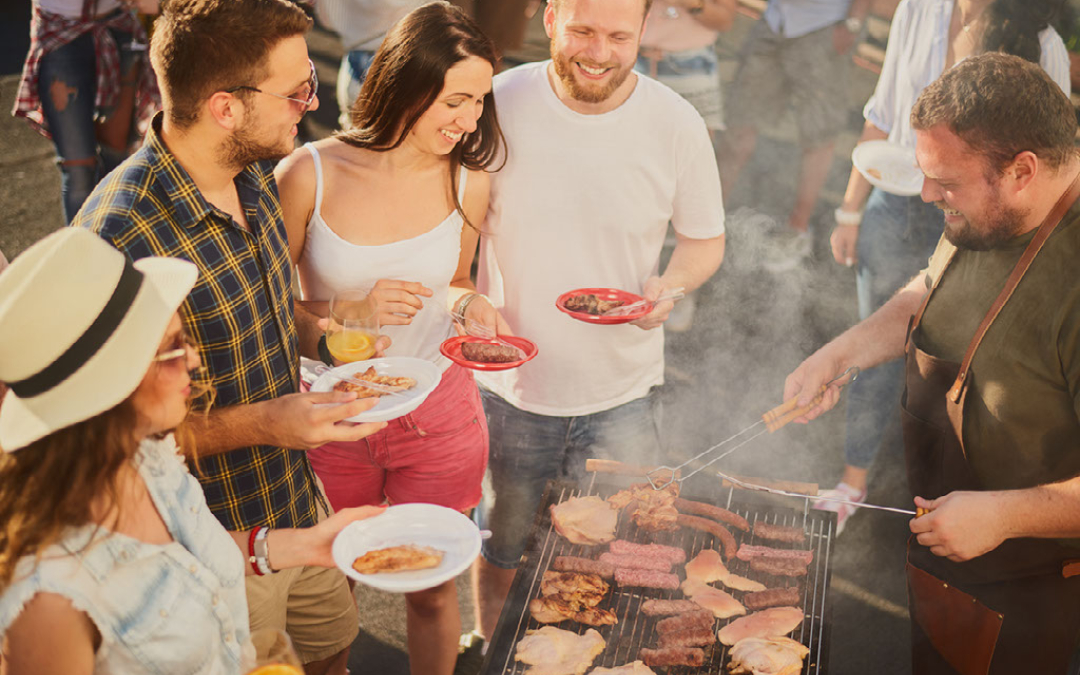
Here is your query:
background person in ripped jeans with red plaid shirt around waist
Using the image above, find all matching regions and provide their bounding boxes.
[12,0,160,222]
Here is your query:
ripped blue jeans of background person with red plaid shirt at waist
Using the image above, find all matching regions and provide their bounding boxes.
[38,24,139,222]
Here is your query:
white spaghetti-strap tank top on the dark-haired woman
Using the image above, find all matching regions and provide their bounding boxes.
[296,143,468,370]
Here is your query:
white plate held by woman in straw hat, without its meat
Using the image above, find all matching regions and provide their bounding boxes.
[332,504,481,593]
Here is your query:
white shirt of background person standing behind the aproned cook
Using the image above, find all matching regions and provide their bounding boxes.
[863,0,1071,148]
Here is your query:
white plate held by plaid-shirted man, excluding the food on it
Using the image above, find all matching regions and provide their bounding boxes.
[311,356,443,422]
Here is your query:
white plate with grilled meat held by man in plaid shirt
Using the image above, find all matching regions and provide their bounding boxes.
[311,356,443,422]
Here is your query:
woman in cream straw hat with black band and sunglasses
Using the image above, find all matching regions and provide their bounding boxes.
[0,228,380,673]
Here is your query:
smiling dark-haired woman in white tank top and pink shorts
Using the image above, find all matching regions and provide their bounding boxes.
[276,3,509,675]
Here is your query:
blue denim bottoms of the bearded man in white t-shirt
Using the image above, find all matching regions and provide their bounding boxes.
[475,388,662,569]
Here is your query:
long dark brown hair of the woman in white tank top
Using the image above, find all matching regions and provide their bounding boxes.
[335,2,505,229]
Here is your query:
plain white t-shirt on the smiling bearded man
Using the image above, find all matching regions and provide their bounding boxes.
[477,62,724,416]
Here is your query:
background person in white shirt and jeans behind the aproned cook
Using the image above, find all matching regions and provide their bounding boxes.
[816,0,1069,531]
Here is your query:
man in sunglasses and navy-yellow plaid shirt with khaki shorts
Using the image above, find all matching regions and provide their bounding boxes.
[73,0,383,674]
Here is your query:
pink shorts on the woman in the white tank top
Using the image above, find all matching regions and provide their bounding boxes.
[308,364,487,511]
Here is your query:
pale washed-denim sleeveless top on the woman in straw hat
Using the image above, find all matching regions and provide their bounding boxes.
[0,436,249,675]
